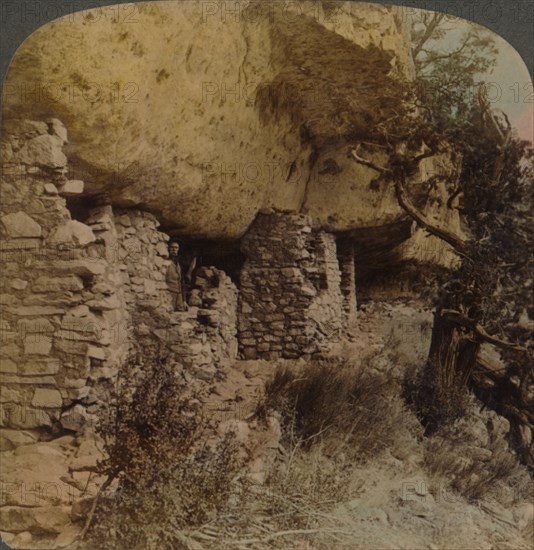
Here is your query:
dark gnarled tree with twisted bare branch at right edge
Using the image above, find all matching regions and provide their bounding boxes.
[352,12,534,466]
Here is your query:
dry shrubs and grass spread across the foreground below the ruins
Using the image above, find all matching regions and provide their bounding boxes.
[84,354,532,550]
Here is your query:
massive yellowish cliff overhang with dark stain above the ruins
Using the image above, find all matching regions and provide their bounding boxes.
[3,2,422,238]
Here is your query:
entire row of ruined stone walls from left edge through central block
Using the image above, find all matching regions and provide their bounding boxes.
[0,119,362,545]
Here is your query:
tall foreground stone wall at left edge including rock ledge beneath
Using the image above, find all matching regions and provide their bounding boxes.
[0,119,126,548]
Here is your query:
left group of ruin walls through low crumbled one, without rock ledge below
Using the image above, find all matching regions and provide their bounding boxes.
[0,121,237,447]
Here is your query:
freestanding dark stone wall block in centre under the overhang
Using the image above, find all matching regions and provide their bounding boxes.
[239,213,346,359]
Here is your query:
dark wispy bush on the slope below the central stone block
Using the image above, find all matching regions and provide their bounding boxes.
[258,358,417,460]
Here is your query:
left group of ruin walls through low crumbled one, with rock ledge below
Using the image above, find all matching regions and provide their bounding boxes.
[0,120,237,546]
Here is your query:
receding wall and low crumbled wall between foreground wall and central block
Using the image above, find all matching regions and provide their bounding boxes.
[109,209,237,380]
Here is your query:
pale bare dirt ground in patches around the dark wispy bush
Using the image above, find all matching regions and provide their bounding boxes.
[183,300,534,550]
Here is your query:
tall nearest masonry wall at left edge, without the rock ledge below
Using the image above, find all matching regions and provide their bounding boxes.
[0,120,124,440]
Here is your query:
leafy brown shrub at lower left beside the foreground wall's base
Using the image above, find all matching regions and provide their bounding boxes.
[87,347,239,549]
